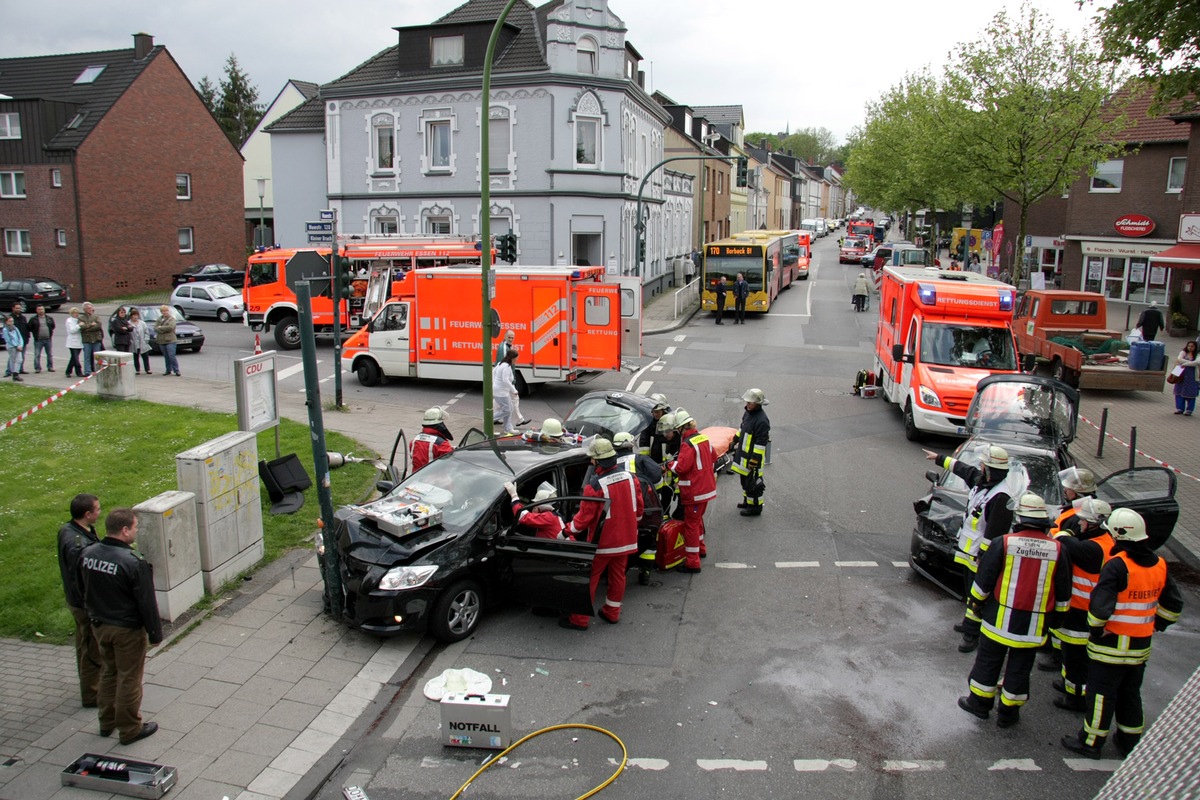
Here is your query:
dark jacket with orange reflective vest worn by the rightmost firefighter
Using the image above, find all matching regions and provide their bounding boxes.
[1087,543,1183,664]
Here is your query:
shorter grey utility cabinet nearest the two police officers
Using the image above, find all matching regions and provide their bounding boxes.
[133,492,204,621]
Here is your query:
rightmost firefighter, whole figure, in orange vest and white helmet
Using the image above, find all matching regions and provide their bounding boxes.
[1062,509,1183,758]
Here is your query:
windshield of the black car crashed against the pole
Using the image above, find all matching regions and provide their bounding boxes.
[389,450,512,534]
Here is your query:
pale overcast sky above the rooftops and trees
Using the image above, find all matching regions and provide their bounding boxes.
[0,0,1094,139]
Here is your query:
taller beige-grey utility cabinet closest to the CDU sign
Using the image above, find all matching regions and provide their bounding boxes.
[175,431,263,593]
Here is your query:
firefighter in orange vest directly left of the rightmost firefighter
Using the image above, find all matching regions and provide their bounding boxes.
[1050,498,1112,711]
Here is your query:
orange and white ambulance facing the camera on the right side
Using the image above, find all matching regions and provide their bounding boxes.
[875,266,1018,441]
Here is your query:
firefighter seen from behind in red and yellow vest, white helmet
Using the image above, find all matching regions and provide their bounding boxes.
[959,492,1070,728]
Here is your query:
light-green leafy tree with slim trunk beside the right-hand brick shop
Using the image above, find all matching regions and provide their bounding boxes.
[941,4,1128,283]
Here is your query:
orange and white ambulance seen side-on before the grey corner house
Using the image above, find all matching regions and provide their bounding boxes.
[342,264,641,386]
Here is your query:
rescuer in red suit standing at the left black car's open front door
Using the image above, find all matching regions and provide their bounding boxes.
[558,439,644,631]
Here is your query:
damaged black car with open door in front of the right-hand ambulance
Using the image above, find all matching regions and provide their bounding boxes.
[908,374,1178,597]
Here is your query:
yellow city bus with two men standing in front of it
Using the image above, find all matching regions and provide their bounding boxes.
[701,230,809,312]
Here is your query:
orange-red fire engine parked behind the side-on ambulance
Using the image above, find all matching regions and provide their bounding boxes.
[242,235,494,350]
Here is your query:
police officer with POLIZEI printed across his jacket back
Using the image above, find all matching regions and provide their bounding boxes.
[79,509,162,745]
